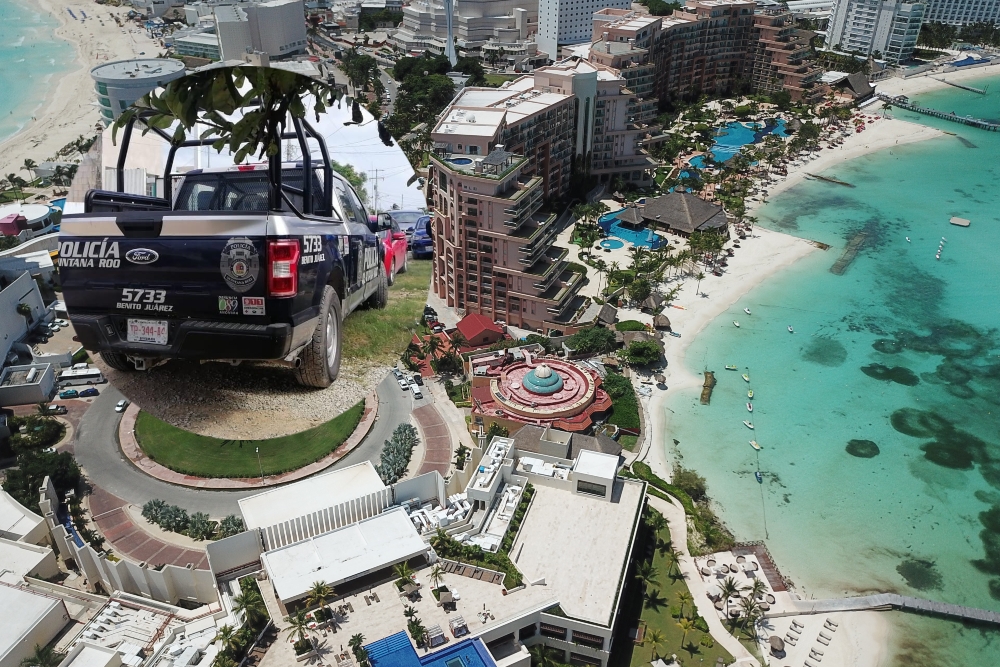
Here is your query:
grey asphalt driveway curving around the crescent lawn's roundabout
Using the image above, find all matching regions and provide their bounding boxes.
[73,375,420,518]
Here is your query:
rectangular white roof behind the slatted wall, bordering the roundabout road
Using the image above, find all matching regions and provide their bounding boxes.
[239,461,385,528]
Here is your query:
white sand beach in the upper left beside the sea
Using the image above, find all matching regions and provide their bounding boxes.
[0,0,163,174]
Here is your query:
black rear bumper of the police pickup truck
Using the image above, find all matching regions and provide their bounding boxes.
[72,315,316,360]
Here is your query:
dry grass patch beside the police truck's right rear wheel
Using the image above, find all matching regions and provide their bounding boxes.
[341,259,432,363]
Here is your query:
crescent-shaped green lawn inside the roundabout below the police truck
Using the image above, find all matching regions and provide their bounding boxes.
[135,401,365,477]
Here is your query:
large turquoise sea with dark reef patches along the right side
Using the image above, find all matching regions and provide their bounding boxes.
[668,79,1000,666]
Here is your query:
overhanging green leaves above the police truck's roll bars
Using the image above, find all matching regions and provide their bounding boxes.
[112,65,339,163]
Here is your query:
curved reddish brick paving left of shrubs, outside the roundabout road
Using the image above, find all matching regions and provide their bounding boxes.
[88,487,208,570]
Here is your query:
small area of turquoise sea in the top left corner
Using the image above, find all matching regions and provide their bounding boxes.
[0,0,76,145]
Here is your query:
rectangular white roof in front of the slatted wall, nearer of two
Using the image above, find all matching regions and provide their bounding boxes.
[261,507,428,603]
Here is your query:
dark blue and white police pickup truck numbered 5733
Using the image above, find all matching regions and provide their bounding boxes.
[58,115,388,387]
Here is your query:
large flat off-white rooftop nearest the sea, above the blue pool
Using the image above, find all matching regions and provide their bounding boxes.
[510,480,642,627]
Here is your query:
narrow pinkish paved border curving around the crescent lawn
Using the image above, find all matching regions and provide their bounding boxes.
[118,394,378,491]
